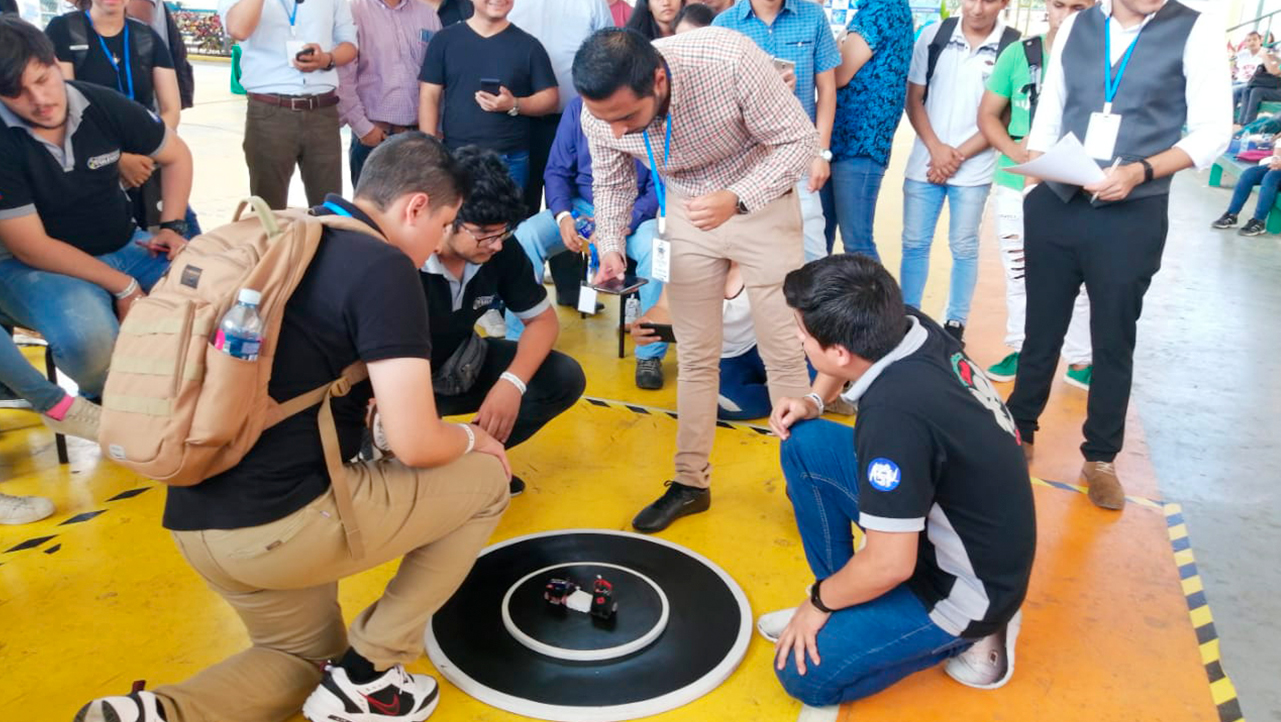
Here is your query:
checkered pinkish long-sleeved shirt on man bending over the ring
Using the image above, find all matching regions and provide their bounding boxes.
[583,28,819,253]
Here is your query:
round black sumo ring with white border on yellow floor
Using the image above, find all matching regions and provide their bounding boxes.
[425,530,752,722]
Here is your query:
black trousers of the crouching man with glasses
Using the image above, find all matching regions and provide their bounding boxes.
[436,338,587,449]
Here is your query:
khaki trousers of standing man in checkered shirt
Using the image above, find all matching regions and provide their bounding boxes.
[667,192,810,488]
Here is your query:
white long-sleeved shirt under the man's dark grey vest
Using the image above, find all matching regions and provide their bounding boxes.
[1027,0,1232,170]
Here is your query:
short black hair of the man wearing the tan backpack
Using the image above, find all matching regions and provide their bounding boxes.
[356,131,471,210]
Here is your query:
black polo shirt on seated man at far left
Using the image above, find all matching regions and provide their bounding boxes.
[0,81,165,256]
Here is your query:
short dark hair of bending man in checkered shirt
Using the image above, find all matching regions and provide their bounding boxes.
[574,28,662,100]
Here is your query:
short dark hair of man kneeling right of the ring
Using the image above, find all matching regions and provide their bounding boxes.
[783,253,906,362]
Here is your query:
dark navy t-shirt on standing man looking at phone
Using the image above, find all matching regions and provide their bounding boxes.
[418,23,556,152]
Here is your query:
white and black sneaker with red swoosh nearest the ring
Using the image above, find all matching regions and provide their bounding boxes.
[302,664,441,722]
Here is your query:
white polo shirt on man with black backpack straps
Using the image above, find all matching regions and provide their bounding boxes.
[907,20,1006,186]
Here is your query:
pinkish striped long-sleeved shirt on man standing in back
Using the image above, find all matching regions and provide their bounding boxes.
[338,0,441,138]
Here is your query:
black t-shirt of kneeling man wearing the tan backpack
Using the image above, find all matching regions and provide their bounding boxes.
[164,196,432,531]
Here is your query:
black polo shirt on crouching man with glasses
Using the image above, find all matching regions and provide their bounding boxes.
[419,240,551,369]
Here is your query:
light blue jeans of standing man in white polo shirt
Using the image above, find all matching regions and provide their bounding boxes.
[898,181,991,324]
